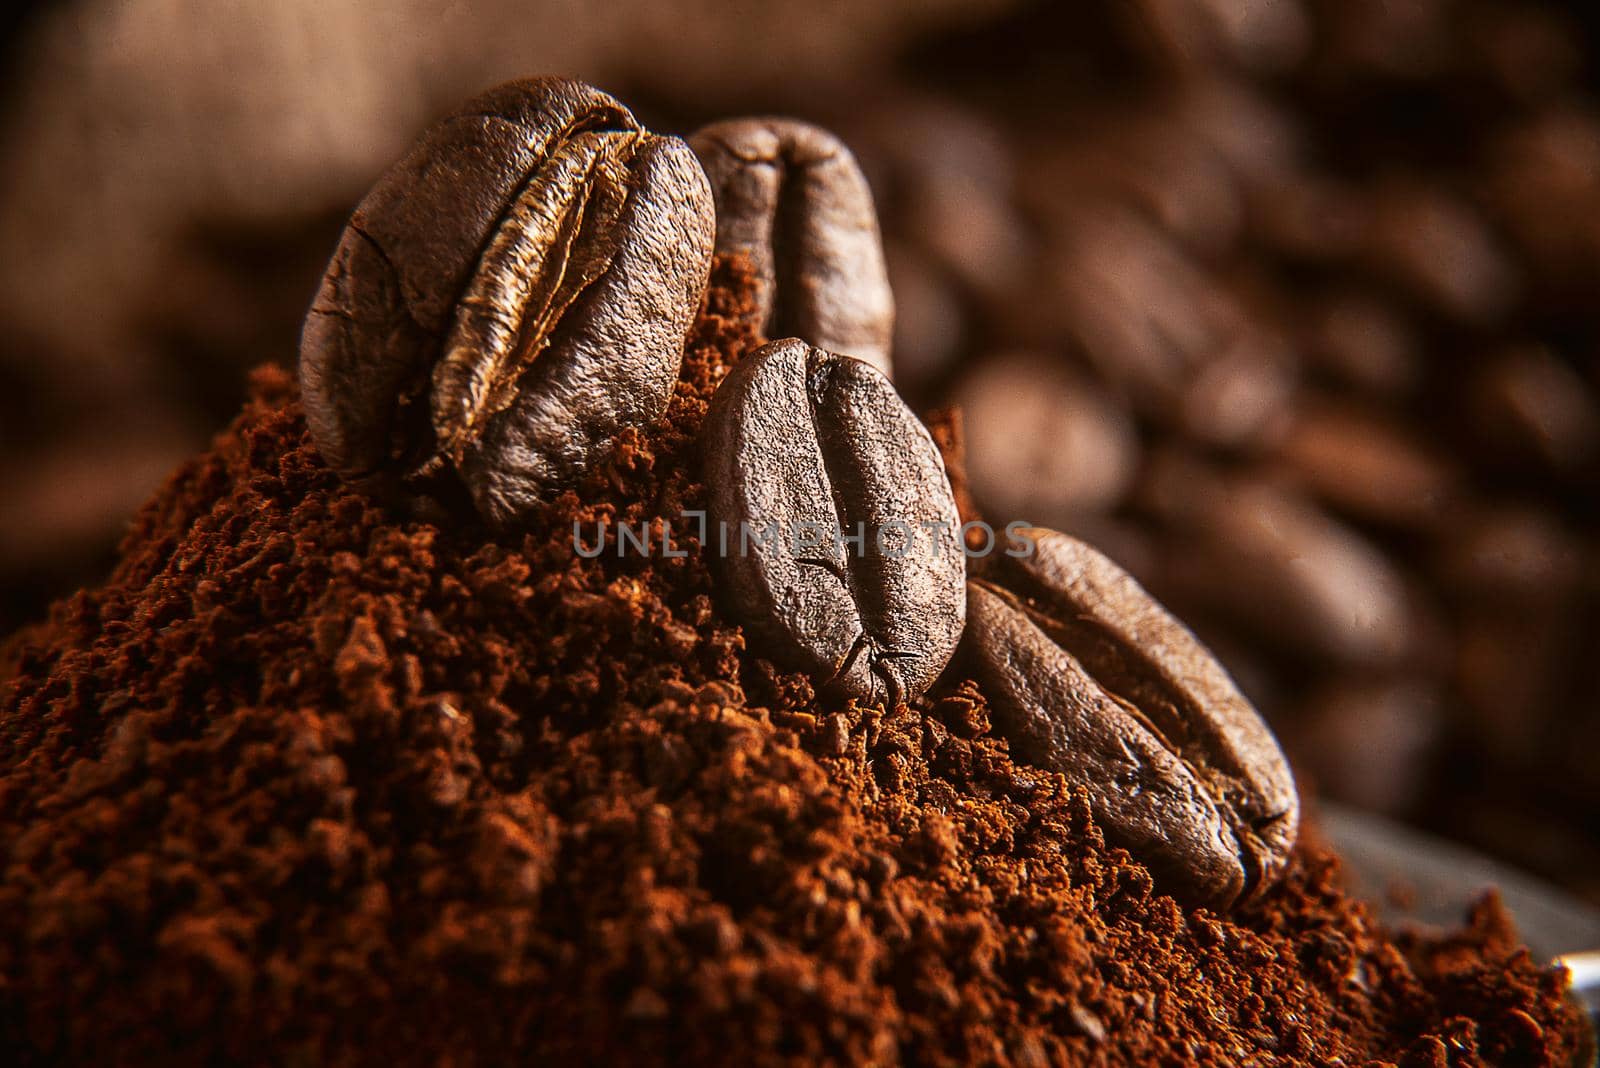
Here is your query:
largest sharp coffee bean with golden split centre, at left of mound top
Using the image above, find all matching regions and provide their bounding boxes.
[301,78,714,524]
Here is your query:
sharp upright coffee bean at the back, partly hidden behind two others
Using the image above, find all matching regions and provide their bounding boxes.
[690,118,894,374]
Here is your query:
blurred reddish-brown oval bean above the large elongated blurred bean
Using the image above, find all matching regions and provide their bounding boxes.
[1275,403,1458,528]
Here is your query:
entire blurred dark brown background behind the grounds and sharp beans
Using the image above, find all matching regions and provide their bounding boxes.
[0,0,1600,900]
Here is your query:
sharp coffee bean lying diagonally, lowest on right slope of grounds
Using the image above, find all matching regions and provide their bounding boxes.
[963,529,1299,908]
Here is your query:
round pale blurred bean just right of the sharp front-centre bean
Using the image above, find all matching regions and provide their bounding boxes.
[955,352,1139,526]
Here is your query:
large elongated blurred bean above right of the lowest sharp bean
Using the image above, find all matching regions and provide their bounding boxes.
[1141,456,1413,665]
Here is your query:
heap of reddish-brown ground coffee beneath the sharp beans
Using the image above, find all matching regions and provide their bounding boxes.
[0,262,1578,1065]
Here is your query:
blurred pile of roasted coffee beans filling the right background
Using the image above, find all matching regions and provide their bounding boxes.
[838,0,1600,897]
